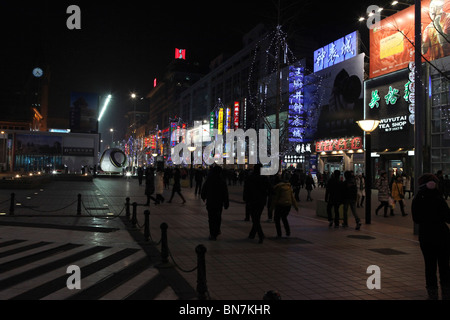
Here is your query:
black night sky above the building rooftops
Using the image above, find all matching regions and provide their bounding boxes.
[0,0,386,140]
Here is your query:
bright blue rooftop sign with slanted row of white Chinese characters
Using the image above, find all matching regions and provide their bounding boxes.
[314,31,359,72]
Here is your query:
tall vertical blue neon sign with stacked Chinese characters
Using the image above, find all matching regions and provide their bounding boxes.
[289,66,306,143]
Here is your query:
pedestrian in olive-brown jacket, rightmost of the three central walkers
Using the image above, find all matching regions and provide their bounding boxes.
[271,180,298,238]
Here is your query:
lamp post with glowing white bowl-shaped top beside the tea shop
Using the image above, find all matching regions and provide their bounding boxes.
[356,120,380,224]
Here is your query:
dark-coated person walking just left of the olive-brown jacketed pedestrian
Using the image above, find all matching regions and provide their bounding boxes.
[243,164,269,243]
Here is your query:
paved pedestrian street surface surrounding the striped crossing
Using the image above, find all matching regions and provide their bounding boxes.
[0,178,434,300]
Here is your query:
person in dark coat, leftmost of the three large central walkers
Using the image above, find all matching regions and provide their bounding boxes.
[200,166,230,240]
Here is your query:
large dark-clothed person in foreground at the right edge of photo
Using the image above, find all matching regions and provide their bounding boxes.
[411,173,450,300]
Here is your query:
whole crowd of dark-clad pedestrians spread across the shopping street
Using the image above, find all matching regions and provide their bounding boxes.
[132,164,450,299]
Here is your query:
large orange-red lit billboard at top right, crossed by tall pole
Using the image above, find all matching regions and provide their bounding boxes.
[369,0,450,78]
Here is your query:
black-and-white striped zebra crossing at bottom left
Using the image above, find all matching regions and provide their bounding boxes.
[0,239,179,300]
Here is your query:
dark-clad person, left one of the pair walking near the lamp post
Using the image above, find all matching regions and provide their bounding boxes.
[325,170,343,228]
